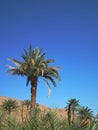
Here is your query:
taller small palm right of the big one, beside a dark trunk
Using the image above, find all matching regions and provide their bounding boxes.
[67,98,79,123]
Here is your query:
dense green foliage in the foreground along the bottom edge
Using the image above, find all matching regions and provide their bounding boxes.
[0,106,98,130]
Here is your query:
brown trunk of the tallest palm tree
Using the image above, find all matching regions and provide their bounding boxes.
[31,78,38,108]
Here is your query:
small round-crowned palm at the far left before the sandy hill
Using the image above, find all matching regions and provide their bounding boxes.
[1,99,18,115]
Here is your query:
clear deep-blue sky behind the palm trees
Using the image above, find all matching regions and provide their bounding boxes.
[0,0,98,113]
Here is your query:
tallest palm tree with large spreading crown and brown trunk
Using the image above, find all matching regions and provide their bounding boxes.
[7,45,60,107]
